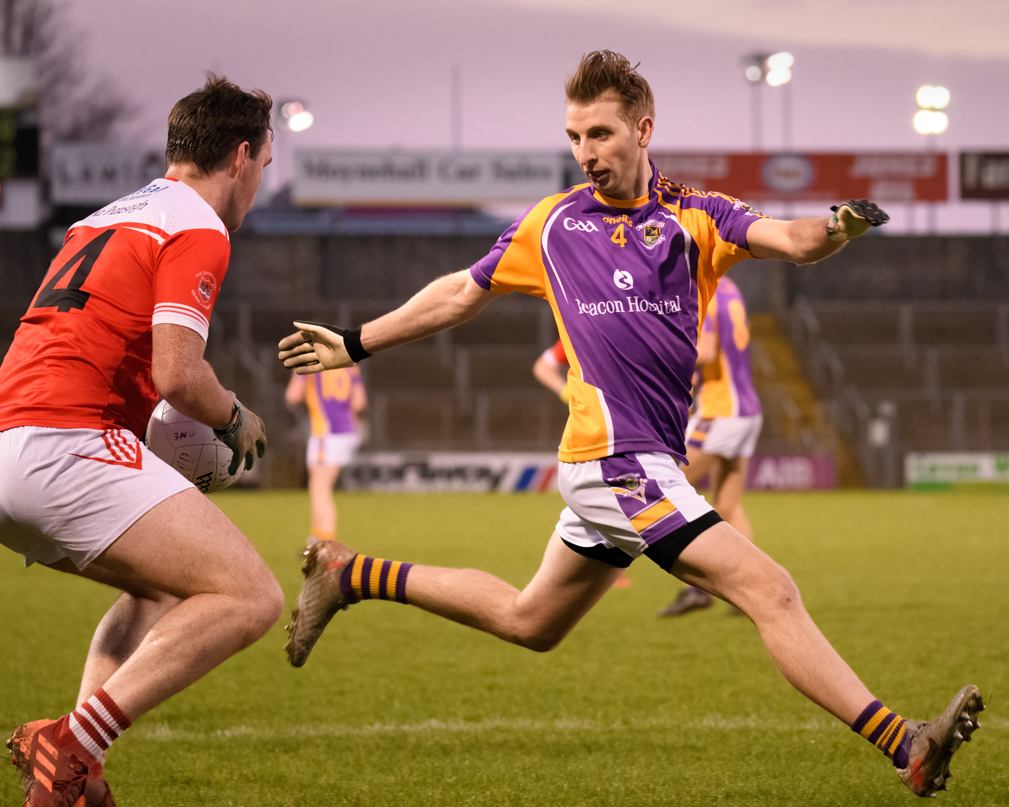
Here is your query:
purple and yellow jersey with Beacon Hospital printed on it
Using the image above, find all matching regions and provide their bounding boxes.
[470,160,760,462]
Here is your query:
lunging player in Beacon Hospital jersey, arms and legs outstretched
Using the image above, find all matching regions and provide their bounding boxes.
[279,50,984,795]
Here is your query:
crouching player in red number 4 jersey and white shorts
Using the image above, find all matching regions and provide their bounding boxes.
[0,76,284,807]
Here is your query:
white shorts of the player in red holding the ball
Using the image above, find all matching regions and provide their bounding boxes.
[0,426,193,569]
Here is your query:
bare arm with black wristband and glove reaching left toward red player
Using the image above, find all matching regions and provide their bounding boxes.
[279,269,496,375]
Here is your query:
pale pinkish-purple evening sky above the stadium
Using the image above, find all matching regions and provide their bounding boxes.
[68,0,1009,229]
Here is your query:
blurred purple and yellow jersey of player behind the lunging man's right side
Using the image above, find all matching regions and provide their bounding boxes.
[697,277,761,419]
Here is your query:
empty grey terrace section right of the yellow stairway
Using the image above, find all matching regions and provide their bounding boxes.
[791,297,1009,486]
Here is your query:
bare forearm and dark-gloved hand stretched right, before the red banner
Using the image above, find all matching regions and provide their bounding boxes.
[747,199,890,263]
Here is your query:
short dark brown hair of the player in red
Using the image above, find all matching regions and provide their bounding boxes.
[164,73,273,174]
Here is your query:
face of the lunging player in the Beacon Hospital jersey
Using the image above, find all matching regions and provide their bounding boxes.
[565,90,651,199]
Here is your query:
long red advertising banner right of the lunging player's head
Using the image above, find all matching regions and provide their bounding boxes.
[649,151,948,202]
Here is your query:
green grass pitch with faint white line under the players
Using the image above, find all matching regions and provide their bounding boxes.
[0,491,1009,807]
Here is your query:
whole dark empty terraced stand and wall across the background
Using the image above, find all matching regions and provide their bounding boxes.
[0,224,1009,486]
